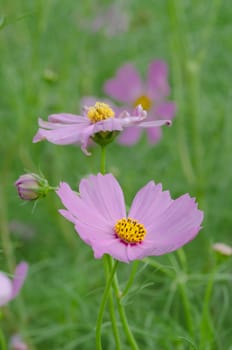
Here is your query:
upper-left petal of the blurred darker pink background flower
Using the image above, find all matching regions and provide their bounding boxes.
[104,63,143,104]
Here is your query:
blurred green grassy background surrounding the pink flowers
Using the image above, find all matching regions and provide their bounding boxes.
[0,0,232,350]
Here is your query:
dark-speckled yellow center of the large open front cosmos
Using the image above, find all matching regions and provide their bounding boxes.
[114,218,147,244]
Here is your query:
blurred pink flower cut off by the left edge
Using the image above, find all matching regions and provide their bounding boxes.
[0,262,28,306]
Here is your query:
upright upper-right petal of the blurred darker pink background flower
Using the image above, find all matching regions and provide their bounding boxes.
[147,61,170,101]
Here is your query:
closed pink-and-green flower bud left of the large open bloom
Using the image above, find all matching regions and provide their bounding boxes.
[15,173,52,201]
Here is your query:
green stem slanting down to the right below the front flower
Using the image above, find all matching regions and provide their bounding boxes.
[107,256,139,350]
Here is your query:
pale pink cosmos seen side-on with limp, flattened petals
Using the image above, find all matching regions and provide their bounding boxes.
[33,102,171,155]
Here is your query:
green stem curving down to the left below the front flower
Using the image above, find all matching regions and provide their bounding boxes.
[96,256,118,350]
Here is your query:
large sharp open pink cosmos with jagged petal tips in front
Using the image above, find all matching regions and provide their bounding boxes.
[57,174,203,263]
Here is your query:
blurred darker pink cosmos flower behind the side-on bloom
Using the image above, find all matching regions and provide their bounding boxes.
[104,60,176,145]
